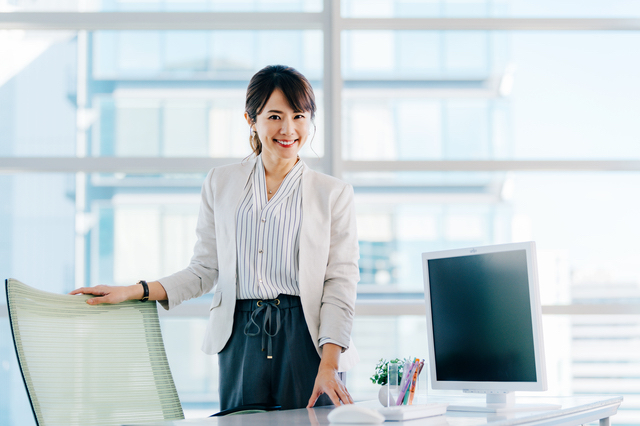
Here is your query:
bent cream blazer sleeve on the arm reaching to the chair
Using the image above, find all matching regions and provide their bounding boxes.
[158,169,218,309]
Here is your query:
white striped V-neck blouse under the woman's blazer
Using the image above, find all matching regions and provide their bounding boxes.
[236,155,303,299]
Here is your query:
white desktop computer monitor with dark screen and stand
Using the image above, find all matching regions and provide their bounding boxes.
[422,242,547,411]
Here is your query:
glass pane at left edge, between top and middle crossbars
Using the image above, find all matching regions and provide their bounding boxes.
[0,30,78,157]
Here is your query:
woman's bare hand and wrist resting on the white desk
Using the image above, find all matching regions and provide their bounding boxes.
[307,343,353,408]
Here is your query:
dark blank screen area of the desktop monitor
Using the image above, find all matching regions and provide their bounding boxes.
[428,250,536,382]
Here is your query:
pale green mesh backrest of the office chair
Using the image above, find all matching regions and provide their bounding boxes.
[6,279,184,426]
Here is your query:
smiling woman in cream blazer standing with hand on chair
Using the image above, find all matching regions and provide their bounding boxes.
[72,65,359,410]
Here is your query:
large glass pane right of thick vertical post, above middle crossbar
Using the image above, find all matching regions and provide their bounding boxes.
[342,31,640,160]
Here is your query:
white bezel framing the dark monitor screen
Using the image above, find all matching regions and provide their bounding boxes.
[422,241,547,392]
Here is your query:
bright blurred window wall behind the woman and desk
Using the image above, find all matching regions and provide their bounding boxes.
[0,0,640,425]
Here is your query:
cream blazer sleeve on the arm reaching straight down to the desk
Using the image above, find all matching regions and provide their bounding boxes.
[319,185,360,349]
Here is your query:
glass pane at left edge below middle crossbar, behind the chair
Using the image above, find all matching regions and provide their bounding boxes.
[0,174,78,426]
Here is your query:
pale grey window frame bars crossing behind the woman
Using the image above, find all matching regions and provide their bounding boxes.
[0,5,640,420]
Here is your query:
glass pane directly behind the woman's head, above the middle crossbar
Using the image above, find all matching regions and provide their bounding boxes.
[87,31,323,159]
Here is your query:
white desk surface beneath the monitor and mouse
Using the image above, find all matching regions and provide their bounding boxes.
[126,395,622,426]
